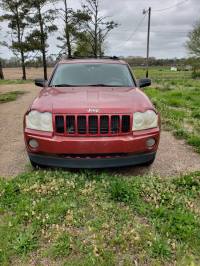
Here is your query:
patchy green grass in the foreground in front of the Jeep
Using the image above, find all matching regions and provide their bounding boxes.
[0,171,200,265]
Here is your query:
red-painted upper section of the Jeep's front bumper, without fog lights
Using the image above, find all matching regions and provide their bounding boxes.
[25,128,159,155]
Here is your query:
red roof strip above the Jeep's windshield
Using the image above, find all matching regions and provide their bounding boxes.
[58,58,127,65]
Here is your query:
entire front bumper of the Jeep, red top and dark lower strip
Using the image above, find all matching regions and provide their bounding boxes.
[24,128,160,168]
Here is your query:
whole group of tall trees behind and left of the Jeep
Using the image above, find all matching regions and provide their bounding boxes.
[0,0,118,80]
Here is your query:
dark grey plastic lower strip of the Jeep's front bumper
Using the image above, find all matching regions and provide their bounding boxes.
[29,152,156,169]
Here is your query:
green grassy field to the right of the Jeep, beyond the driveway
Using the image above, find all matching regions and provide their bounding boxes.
[136,68,200,153]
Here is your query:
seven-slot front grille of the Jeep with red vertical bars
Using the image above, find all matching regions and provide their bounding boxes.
[55,115,131,136]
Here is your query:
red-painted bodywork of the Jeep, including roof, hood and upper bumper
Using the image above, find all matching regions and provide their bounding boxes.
[24,59,160,168]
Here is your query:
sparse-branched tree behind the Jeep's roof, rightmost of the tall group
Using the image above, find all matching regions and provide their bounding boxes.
[83,0,118,57]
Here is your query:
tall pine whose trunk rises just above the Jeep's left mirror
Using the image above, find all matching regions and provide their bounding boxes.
[26,0,57,80]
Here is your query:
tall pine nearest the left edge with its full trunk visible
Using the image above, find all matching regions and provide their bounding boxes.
[0,0,29,80]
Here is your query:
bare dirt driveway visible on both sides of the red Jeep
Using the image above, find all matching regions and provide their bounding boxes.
[0,84,200,178]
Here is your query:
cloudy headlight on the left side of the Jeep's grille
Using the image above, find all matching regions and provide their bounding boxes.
[26,111,53,132]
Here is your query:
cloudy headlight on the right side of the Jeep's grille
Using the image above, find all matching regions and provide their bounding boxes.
[133,110,158,131]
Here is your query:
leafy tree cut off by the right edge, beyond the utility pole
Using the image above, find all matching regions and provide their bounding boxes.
[186,21,200,57]
